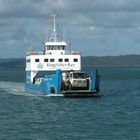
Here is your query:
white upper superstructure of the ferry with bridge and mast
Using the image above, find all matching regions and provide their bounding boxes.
[26,15,81,81]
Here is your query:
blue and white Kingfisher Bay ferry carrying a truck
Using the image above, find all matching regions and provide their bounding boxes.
[25,14,99,97]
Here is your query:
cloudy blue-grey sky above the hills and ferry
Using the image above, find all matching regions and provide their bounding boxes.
[0,0,140,58]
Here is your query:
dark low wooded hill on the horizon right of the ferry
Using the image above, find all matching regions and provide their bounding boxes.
[82,55,140,67]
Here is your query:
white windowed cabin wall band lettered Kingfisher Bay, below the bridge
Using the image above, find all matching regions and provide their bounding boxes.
[26,55,81,71]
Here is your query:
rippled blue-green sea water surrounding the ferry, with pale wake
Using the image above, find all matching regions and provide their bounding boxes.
[0,68,140,140]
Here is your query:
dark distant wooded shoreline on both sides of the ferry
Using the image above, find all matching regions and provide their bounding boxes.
[0,55,140,69]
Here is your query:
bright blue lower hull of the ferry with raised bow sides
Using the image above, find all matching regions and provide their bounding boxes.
[25,69,99,97]
